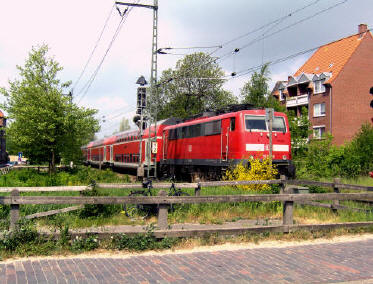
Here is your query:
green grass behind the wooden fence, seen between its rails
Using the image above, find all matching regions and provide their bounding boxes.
[0,168,373,229]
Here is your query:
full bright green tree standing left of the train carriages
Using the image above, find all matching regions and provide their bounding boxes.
[0,45,99,171]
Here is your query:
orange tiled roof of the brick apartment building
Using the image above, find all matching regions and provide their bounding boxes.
[294,33,371,83]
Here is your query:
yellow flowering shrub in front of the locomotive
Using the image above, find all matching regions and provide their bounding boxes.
[224,158,278,191]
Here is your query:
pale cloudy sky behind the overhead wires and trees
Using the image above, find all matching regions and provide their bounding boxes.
[0,0,373,138]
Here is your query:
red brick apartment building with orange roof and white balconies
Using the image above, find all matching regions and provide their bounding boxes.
[272,24,373,145]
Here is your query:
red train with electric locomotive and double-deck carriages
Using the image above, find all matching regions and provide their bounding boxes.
[82,105,295,178]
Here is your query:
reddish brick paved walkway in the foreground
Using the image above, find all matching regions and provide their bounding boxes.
[0,239,373,284]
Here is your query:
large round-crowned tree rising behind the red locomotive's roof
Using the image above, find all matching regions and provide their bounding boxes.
[155,52,236,119]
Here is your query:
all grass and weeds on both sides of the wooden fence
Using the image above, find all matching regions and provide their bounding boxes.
[0,168,373,258]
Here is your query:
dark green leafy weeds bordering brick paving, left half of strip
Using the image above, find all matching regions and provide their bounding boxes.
[0,220,180,260]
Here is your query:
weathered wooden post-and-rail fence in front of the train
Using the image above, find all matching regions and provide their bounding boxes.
[0,178,373,238]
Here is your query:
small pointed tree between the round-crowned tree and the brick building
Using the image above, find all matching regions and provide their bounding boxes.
[241,64,285,111]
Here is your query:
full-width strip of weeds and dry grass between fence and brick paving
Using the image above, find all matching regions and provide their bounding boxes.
[0,217,373,260]
